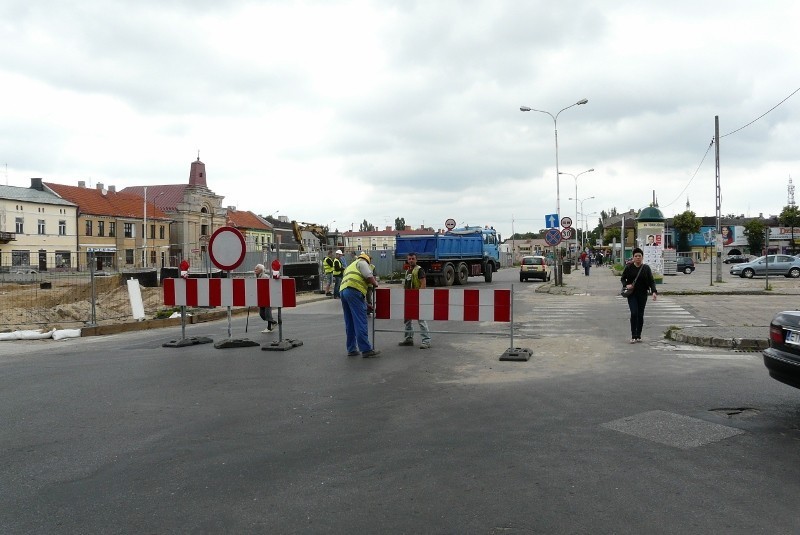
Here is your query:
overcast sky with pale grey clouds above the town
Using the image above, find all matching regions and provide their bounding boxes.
[0,0,800,236]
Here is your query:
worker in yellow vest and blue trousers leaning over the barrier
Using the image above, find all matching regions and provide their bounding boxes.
[339,253,380,358]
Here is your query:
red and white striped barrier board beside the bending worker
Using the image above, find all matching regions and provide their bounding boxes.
[375,288,511,322]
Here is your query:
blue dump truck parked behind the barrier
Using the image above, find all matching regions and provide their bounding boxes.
[394,227,500,286]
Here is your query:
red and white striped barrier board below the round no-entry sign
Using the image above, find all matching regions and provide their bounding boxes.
[162,277,297,308]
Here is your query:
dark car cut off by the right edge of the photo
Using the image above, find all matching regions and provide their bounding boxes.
[762,310,800,388]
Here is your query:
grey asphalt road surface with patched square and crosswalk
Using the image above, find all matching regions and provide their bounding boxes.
[0,270,800,534]
